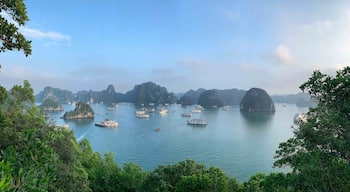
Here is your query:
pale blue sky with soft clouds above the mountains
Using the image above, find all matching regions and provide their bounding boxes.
[0,0,350,94]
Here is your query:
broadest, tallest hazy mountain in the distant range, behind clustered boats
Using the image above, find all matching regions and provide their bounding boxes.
[123,82,176,106]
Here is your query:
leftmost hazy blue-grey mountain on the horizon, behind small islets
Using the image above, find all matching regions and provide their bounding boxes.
[35,87,74,104]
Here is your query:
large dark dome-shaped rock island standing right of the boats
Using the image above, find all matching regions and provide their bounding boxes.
[240,88,275,112]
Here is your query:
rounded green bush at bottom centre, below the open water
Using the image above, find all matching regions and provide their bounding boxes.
[143,160,239,191]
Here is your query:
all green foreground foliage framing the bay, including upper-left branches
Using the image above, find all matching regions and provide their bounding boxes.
[0,0,350,192]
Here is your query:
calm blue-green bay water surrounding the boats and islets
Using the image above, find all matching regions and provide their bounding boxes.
[51,104,307,181]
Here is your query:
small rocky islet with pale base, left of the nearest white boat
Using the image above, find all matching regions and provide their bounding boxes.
[63,102,95,119]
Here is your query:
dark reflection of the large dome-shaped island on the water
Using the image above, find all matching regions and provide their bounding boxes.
[241,112,275,128]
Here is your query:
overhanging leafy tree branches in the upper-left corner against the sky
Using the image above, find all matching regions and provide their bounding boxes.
[0,0,32,56]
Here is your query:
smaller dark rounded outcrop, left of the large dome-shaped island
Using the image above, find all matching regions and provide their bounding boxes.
[198,89,224,109]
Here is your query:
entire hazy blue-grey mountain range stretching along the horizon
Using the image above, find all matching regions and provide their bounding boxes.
[35,82,315,107]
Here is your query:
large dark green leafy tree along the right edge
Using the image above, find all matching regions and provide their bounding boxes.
[274,67,350,191]
